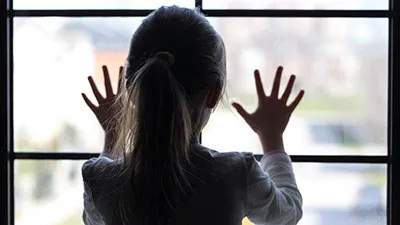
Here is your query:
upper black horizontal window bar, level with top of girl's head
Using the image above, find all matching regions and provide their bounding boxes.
[8,9,393,18]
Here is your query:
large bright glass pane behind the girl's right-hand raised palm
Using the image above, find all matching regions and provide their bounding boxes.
[203,18,388,155]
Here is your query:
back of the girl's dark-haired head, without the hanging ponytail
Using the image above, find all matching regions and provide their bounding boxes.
[126,6,226,135]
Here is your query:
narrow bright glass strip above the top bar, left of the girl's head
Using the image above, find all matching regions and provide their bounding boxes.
[14,0,195,9]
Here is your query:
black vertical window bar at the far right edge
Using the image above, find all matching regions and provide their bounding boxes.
[387,0,400,225]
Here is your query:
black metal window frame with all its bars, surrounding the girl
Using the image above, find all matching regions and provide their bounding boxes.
[0,0,400,225]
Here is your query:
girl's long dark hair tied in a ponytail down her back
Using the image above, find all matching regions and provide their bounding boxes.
[111,6,226,225]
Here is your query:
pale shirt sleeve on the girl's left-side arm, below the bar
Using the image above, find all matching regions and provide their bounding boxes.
[82,154,112,225]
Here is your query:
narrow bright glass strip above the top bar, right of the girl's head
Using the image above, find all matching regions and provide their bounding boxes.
[203,0,389,10]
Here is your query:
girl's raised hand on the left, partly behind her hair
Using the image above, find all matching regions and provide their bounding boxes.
[82,66,123,134]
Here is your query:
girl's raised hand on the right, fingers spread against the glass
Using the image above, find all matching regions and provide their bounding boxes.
[232,66,304,152]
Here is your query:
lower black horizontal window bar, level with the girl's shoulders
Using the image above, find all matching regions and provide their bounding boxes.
[10,152,390,163]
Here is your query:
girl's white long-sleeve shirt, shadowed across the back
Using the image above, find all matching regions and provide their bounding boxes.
[82,144,302,225]
